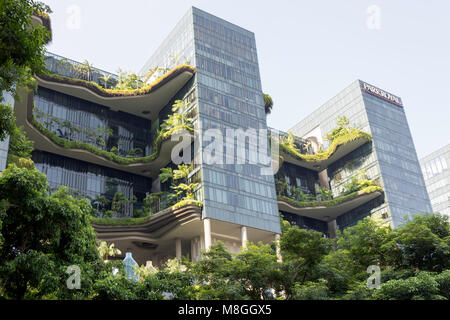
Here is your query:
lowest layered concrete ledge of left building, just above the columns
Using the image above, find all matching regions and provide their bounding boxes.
[92,205,202,242]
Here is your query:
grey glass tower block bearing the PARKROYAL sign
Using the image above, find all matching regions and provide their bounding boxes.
[292,80,431,227]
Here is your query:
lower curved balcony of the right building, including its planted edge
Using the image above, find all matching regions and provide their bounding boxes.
[278,186,383,222]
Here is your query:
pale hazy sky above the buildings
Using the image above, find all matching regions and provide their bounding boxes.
[41,0,450,158]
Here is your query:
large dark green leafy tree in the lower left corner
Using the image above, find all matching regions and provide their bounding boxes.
[0,164,103,299]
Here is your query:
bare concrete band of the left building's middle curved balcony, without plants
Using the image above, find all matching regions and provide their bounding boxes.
[14,89,191,177]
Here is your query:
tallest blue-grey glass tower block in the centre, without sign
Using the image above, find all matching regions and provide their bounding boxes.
[141,8,281,233]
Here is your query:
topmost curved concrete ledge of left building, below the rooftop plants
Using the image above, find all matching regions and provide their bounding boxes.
[35,65,195,120]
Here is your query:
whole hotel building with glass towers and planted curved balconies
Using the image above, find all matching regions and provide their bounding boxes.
[2,7,431,265]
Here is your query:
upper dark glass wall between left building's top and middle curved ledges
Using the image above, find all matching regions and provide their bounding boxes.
[34,87,153,157]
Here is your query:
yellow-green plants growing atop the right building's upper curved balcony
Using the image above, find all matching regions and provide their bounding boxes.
[279,117,372,162]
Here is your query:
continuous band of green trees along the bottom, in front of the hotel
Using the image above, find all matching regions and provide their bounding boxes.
[0,160,450,299]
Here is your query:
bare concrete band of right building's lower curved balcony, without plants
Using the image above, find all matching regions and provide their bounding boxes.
[278,191,382,222]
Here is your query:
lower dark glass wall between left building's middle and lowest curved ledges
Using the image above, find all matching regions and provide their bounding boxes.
[32,151,152,217]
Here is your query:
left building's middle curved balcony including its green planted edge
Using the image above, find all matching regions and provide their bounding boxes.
[14,89,193,177]
